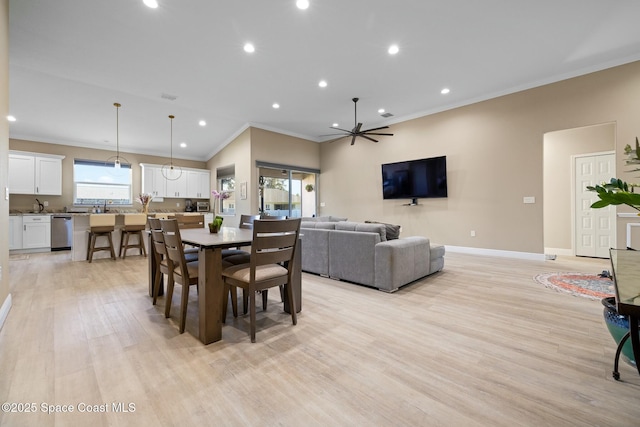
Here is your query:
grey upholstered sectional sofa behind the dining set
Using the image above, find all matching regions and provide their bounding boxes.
[300,217,444,292]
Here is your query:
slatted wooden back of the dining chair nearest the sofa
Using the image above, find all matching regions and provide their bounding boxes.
[251,218,300,269]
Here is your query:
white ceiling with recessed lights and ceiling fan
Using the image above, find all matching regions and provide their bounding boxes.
[9,0,640,160]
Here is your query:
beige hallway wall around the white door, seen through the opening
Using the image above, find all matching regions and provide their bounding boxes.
[543,123,616,255]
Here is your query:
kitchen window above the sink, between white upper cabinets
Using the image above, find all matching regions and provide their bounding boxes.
[73,159,133,206]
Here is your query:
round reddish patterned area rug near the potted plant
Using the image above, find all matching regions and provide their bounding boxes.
[533,273,615,300]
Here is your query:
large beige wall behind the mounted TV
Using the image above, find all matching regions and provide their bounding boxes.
[319,62,640,254]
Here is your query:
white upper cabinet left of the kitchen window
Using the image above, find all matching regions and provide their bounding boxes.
[9,151,64,196]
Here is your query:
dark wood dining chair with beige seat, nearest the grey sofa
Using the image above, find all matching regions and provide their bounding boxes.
[222,218,300,342]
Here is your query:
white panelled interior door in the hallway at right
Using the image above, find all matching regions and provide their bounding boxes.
[574,154,616,258]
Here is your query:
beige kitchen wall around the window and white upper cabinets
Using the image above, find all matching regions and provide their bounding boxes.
[9,139,206,212]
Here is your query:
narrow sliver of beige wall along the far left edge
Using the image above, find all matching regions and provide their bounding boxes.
[0,0,10,327]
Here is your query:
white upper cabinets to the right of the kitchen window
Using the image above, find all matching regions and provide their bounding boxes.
[140,163,211,201]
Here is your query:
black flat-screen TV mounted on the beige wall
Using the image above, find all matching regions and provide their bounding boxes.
[382,156,447,204]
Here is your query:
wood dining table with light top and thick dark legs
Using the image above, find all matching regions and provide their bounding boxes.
[149,227,302,344]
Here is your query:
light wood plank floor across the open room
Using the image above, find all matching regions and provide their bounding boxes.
[0,252,640,427]
